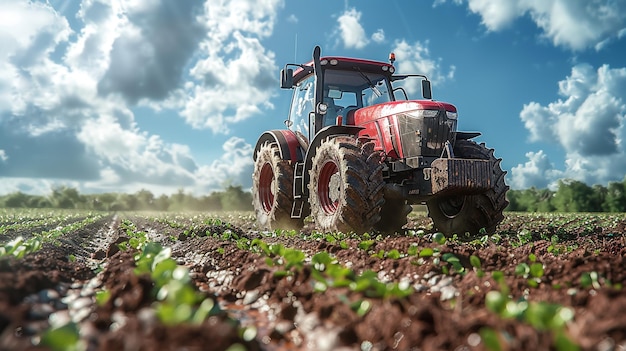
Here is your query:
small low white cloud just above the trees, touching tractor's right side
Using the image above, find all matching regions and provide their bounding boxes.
[511,150,562,189]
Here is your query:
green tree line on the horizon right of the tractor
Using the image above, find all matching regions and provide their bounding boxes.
[507,177,626,212]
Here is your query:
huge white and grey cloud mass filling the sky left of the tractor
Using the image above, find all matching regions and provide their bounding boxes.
[0,0,282,193]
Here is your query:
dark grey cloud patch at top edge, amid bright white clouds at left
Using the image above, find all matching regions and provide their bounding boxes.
[98,1,205,104]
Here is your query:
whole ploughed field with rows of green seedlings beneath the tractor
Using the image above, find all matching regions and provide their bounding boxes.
[0,210,626,351]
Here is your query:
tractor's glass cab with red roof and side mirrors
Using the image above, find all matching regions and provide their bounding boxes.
[281,49,431,143]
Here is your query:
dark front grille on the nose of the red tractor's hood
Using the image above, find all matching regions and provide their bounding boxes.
[397,111,456,158]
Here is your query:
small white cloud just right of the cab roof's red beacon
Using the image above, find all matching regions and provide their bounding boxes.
[393,40,456,95]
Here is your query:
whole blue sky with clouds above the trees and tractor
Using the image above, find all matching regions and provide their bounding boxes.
[0,0,626,196]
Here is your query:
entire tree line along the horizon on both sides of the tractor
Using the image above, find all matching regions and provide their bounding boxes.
[0,177,626,212]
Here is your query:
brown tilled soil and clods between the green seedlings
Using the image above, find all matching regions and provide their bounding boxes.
[0,214,626,351]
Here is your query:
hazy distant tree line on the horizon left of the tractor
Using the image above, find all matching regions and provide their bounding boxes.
[0,185,253,211]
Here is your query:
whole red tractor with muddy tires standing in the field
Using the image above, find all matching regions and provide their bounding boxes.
[252,46,509,237]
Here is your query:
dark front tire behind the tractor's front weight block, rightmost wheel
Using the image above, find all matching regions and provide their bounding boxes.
[427,140,509,239]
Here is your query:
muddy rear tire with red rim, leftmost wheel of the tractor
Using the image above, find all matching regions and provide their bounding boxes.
[252,142,304,230]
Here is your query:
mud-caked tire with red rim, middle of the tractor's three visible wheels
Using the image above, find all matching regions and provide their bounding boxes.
[309,136,385,234]
